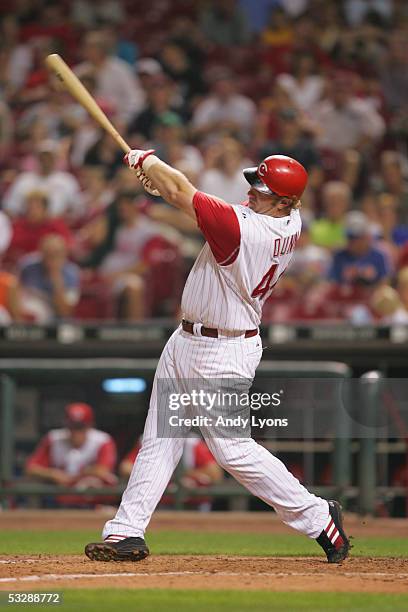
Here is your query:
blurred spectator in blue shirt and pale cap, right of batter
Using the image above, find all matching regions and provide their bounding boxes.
[329,211,390,290]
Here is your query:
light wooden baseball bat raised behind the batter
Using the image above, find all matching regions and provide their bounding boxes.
[45,53,130,153]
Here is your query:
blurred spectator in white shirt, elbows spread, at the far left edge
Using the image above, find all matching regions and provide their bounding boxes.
[3,140,81,217]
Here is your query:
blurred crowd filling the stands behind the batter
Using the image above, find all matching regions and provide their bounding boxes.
[0,0,408,325]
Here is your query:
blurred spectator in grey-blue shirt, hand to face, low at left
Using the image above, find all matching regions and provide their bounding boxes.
[20,234,80,323]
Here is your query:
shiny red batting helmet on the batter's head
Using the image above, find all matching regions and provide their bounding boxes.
[244,155,307,199]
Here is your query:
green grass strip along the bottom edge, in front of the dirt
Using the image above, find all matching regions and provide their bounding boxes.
[17,589,408,612]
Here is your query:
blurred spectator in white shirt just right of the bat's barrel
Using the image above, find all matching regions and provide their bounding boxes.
[76,31,144,124]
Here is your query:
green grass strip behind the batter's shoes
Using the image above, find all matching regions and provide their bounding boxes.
[0,529,408,557]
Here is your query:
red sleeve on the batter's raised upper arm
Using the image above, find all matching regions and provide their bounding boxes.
[193,191,241,266]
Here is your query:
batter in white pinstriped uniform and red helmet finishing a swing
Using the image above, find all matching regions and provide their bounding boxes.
[85,149,350,563]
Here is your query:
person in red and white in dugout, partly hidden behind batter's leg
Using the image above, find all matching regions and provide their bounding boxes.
[119,435,224,512]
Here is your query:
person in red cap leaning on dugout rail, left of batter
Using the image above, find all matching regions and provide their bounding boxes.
[26,403,117,506]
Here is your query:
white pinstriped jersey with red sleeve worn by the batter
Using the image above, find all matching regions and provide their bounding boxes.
[181,192,302,331]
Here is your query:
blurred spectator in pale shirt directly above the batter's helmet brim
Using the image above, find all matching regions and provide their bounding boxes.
[192,68,256,142]
